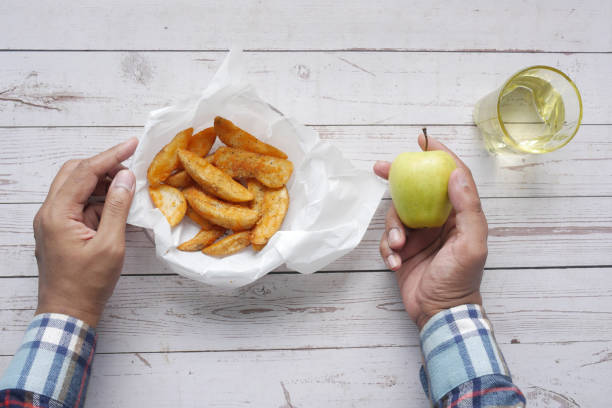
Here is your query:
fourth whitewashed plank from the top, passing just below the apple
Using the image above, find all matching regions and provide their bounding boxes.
[0,197,612,276]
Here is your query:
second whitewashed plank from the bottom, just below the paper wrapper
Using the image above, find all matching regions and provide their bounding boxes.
[0,268,612,355]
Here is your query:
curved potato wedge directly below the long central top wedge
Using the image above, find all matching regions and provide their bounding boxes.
[183,187,259,231]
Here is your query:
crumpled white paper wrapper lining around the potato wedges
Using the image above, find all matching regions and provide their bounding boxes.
[128,51,386,287]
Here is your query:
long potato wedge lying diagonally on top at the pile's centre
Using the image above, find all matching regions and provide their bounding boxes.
[178,149,253,203]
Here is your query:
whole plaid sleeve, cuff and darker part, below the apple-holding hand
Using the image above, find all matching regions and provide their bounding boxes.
[421,305,525,408]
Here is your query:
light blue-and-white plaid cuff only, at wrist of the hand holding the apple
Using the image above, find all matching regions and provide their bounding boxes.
[421,305,510,403]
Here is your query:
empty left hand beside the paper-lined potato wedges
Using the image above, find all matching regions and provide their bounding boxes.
[34,138,138,327]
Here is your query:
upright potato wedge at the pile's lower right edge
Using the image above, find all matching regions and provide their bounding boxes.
[250,187,289,245]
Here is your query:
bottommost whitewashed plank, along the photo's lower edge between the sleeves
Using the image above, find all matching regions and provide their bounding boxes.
[0,341,612,408]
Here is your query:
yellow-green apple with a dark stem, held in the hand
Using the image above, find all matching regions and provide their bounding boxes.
[389,150,457,228]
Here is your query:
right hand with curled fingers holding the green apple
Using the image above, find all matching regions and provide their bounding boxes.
[374,135,488,329]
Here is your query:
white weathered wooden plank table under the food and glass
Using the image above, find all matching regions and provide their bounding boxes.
[0,0,612,407]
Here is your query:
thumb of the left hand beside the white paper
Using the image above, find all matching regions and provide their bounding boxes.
[96,170,136,243]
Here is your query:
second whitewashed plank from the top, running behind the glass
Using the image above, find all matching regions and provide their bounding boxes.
[0,52,612,126]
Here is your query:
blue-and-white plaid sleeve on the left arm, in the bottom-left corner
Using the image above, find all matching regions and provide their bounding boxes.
[0,313,96,408]
